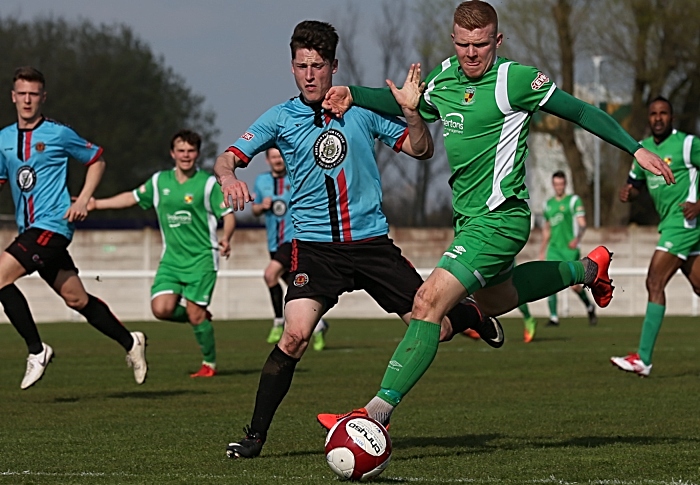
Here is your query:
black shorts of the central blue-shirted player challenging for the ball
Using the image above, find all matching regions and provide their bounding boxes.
[285,236,423,315]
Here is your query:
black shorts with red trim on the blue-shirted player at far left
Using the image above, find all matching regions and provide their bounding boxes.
[5,227,78,286]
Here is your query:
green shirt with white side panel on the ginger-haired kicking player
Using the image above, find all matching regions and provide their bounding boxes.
[419,56,556,216]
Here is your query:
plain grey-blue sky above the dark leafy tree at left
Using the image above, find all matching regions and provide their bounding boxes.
[0,0,392,182]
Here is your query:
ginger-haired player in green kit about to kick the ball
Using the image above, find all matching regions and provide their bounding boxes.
[318,1,673,427]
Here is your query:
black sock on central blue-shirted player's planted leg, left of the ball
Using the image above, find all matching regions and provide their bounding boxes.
[250,345,299,441]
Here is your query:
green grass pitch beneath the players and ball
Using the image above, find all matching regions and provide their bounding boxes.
[0,317,700,485]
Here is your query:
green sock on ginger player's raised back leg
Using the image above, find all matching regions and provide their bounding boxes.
[513,261,586,305]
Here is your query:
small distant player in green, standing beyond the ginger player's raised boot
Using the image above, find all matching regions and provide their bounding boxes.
[540,171,598,326]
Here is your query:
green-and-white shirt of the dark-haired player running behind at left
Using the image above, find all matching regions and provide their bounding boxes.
[133,169,231,273]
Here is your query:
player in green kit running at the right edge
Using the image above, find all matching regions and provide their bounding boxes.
[610,97,700,377]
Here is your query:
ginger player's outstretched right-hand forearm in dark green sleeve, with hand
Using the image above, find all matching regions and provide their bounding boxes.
[542,89,676,184]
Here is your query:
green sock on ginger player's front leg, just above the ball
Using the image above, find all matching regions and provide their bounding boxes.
[377,319,440,406]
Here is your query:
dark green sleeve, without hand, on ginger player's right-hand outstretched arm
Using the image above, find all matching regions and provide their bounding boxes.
[542,89,642,155]
